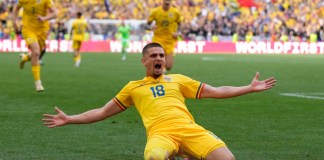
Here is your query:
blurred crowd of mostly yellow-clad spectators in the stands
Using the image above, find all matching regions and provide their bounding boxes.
[0,0,324,42]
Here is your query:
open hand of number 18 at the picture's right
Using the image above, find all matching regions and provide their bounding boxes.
[250,72,277,92]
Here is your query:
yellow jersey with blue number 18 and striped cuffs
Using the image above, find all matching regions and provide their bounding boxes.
[113,74,204,135]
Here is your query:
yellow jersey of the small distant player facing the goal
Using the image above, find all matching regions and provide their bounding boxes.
[72,19,87,41]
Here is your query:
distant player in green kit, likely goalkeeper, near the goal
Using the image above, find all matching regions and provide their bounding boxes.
[118,20,131,61]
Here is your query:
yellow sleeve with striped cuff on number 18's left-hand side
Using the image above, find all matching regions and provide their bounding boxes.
[113,83,133,110]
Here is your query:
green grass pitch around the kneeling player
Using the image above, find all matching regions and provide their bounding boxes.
[0,53,324,160]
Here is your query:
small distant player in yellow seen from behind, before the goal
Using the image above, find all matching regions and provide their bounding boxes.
[70,12,89,67]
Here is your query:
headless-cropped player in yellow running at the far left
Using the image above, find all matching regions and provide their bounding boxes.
[12,0,57,92]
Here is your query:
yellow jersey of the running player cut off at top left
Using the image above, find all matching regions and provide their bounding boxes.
[18,0,54,31]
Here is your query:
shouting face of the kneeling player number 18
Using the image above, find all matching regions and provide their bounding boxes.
[142,47,165,78]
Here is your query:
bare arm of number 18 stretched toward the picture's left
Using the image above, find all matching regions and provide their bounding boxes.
[42,100,123,128]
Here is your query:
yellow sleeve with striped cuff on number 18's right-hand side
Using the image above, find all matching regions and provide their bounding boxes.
[180,75,205,99]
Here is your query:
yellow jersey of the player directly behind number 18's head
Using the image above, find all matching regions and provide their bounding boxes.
[148,6,181,40]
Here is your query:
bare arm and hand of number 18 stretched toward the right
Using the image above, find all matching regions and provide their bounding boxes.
[200,72,277,98]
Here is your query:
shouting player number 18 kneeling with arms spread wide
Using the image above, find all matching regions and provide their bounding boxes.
[42,43,276,160]
